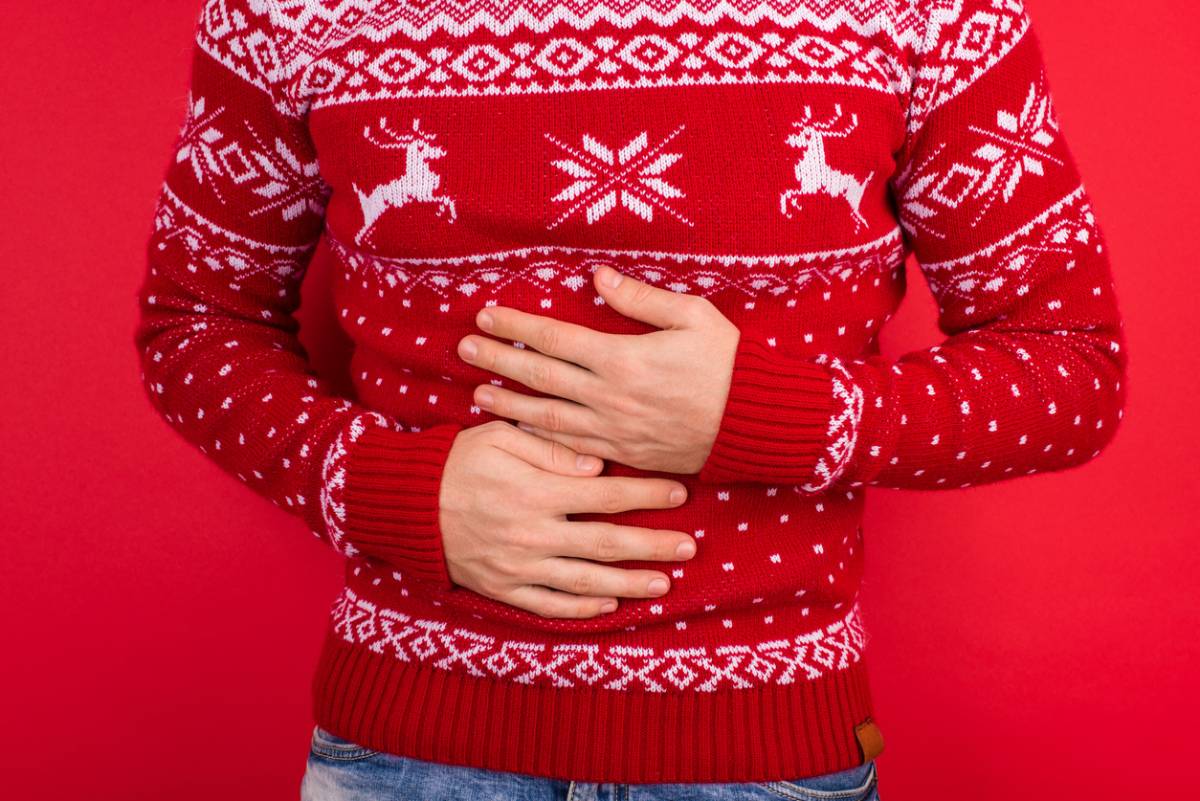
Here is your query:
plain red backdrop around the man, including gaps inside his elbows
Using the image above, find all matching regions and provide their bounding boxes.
[0,0,1200,801]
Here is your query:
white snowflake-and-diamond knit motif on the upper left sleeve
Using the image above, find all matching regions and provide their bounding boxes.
[175,97,325,219]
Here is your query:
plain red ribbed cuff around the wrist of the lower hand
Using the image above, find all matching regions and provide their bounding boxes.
[343,423,462,589]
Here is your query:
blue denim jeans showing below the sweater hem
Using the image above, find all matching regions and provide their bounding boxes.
[300,727,880,801]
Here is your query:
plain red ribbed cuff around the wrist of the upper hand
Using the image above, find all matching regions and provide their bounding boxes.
[698,333,835,486]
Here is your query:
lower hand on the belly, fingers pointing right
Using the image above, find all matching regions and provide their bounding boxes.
[439,420,696,618]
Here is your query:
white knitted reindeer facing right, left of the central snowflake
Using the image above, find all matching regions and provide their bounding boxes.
[352,116,457,245]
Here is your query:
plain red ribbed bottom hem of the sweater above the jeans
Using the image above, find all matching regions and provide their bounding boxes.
[312,606,871,783]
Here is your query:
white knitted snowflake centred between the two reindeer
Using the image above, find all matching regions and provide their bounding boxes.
[546,125,695,229]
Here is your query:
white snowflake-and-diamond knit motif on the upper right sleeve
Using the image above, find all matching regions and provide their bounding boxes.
[896,79,1063,239]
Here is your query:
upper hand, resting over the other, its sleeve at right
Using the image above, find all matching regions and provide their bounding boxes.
[458,266,739,474]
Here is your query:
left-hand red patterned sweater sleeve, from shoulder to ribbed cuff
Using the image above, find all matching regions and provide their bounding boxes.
[134,0,461,586]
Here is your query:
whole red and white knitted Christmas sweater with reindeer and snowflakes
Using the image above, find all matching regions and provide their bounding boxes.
[136,0,1126,782]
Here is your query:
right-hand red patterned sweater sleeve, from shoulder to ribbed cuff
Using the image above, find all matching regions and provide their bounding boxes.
[701,0,1127,493]
